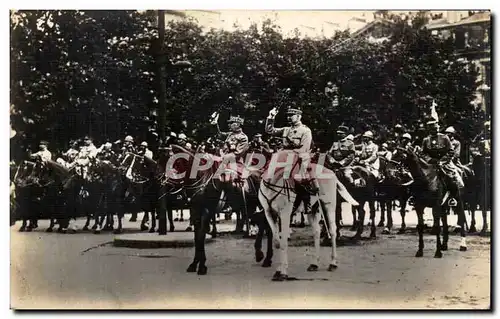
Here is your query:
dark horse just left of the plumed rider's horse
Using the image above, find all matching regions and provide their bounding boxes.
[376,157,412,234]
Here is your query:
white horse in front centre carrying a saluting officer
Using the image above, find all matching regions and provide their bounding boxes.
[259,156,358,281]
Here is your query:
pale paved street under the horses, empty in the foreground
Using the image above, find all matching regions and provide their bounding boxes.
[11,205,491,309]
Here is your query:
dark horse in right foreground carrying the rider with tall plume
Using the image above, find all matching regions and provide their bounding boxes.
[398,148,467,258]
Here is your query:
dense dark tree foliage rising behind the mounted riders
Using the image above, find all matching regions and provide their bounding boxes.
[10,11,481,159]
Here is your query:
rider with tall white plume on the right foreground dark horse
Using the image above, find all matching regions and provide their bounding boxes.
[422,120,464,206]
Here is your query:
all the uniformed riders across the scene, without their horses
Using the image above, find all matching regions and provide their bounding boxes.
[11,108,491,239]
